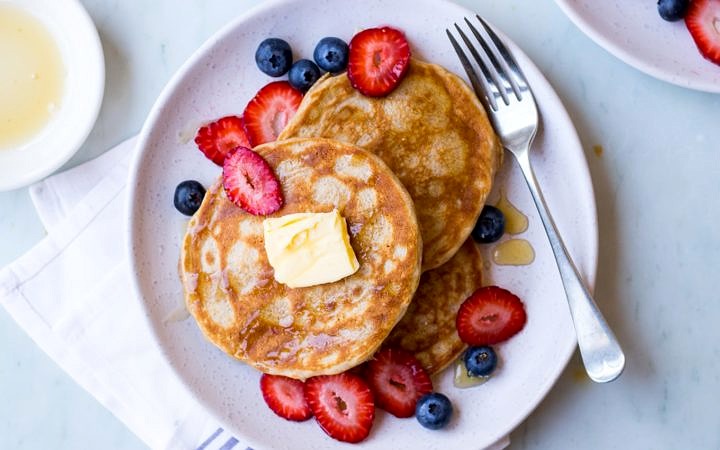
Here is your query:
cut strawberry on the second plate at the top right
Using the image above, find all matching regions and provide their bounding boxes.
[685,0,720,64]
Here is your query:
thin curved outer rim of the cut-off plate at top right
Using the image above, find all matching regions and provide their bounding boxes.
[555,0,720,94]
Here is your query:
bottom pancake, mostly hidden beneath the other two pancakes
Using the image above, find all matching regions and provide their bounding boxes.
[386,238,482,375]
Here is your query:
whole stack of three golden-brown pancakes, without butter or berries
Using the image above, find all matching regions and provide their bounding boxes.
[180,59,502,379]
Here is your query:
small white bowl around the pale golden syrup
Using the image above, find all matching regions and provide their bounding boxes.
[0,0,105,191]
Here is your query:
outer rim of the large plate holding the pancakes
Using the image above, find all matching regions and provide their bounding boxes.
[125,0,599,448]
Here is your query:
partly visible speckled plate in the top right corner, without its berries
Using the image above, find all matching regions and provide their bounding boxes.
[555,0,720,93]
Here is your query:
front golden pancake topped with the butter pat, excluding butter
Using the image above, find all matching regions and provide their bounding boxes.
[180,139,422,379]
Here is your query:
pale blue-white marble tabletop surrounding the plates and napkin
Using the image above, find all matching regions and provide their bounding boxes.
[0,0,720,450]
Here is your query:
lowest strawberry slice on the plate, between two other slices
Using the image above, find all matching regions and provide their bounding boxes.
[305,372,375,442]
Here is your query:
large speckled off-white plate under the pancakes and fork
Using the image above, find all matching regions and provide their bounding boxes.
[128,0,597,449]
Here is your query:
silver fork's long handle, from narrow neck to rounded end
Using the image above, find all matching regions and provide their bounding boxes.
[512,151,625,383]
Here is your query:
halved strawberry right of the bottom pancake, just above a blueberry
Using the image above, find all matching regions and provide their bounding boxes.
[455,286,527,345]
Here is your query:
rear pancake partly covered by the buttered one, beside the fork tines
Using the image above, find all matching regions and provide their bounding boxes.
[279,59,502,270]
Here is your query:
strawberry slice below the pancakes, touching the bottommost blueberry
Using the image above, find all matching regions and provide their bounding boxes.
[365,348,432,417]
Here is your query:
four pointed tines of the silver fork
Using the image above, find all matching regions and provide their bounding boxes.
[445,16,529,111]
